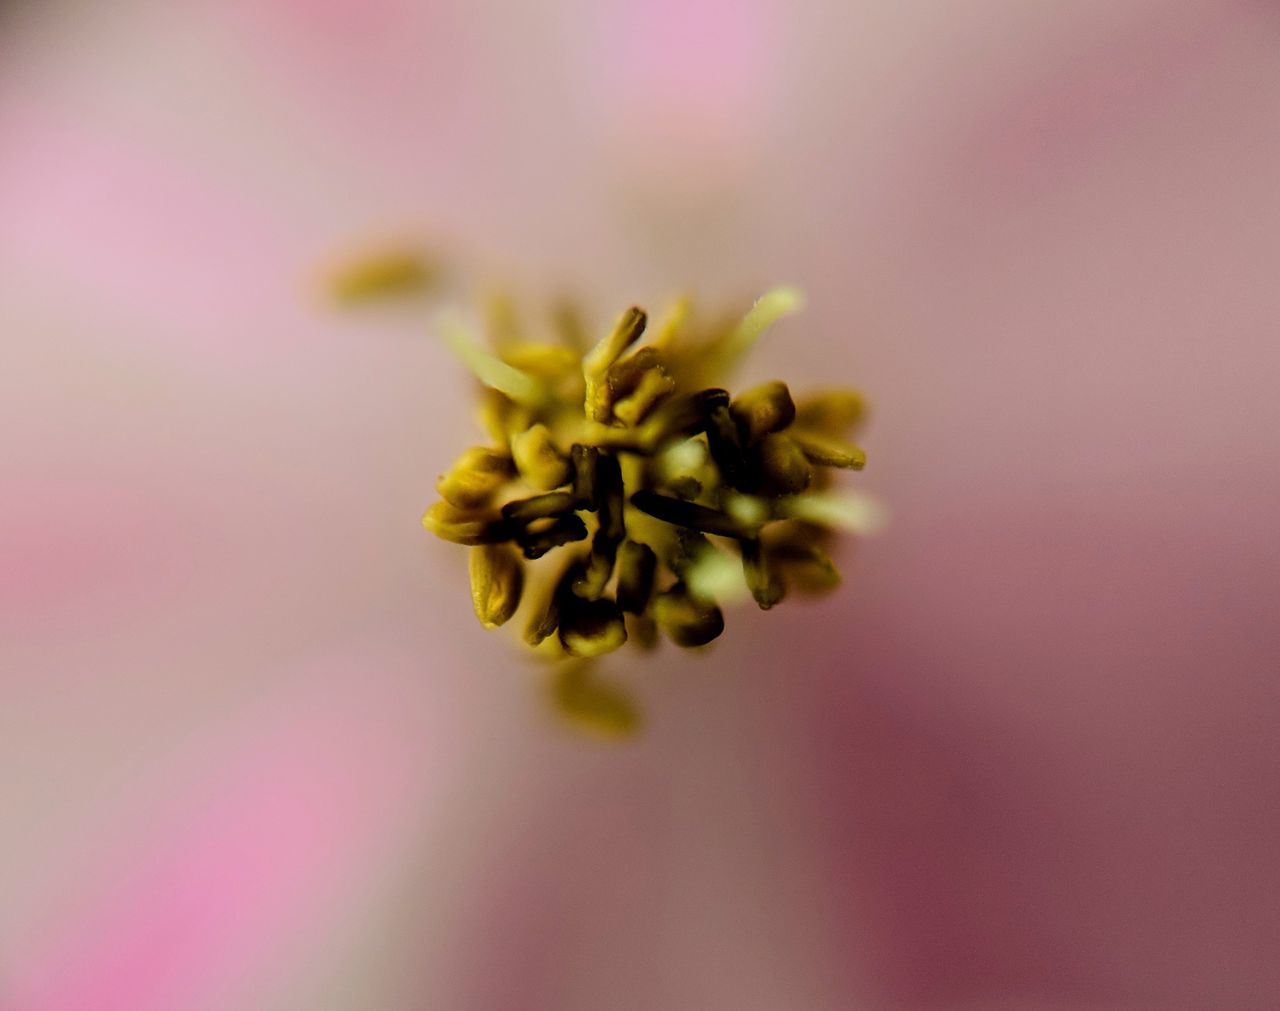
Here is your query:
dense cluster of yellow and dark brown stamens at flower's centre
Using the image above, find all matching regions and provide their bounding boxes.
[422,289,865,658]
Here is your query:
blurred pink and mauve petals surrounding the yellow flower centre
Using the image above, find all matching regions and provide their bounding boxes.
[0,0,1280,1011]
